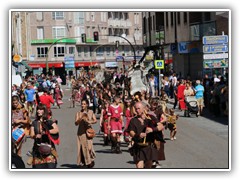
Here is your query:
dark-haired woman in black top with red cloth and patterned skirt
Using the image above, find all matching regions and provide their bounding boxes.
[30,103,59,169]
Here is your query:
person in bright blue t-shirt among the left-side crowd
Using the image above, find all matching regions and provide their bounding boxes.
[24,83,35,117]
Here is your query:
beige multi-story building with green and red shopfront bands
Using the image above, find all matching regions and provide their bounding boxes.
[14,11,143,78]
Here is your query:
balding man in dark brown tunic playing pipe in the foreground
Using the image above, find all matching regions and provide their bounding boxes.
[128,102,163,168]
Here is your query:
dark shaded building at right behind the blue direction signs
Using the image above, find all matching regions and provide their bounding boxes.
[143,11,229,78]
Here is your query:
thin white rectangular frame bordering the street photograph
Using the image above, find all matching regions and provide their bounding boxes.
[8,8,232,172]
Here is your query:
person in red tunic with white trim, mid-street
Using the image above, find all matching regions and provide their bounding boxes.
[108,96,123,154]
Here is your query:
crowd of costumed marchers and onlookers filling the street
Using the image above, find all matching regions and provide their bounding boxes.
[12,66,228,168]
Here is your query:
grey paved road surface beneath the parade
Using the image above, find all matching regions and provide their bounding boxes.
[19,85,229,169]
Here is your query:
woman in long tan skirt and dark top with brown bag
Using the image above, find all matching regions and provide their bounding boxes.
[75,99,97,168]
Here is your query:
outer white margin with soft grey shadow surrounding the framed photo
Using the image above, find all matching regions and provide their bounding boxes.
[0,0,240,180]
